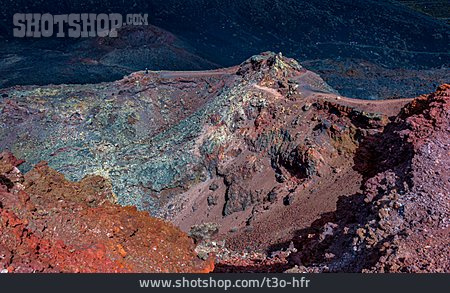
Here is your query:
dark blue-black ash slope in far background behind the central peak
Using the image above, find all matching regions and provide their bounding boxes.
[0,0,449,67]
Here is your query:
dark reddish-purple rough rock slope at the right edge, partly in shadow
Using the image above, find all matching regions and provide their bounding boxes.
[282,85,450,272]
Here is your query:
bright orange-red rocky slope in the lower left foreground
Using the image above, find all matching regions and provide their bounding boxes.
[0,152,214,272]
